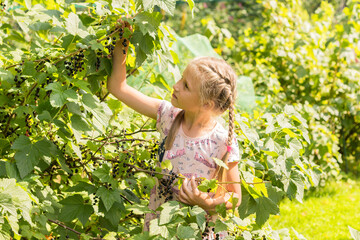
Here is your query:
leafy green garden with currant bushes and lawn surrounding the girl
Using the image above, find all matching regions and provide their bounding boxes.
[0,0,360,239]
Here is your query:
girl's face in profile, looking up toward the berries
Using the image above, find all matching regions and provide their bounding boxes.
[171,65,201,112]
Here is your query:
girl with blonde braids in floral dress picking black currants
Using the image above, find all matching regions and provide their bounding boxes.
[107,23,241,239]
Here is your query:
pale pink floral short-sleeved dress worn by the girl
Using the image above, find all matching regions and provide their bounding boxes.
[144,101,239,239]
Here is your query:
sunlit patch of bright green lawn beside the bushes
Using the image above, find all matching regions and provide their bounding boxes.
[269,179,360,240]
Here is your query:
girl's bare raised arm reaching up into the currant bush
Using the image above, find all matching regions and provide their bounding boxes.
[107,22,161,119]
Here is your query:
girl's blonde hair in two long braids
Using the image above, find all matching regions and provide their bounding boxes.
[165,57,236,193]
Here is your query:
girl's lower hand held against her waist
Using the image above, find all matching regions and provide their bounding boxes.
[178,177,215,211]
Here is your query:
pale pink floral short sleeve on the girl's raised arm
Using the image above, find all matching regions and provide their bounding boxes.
[156,100,181,138]
